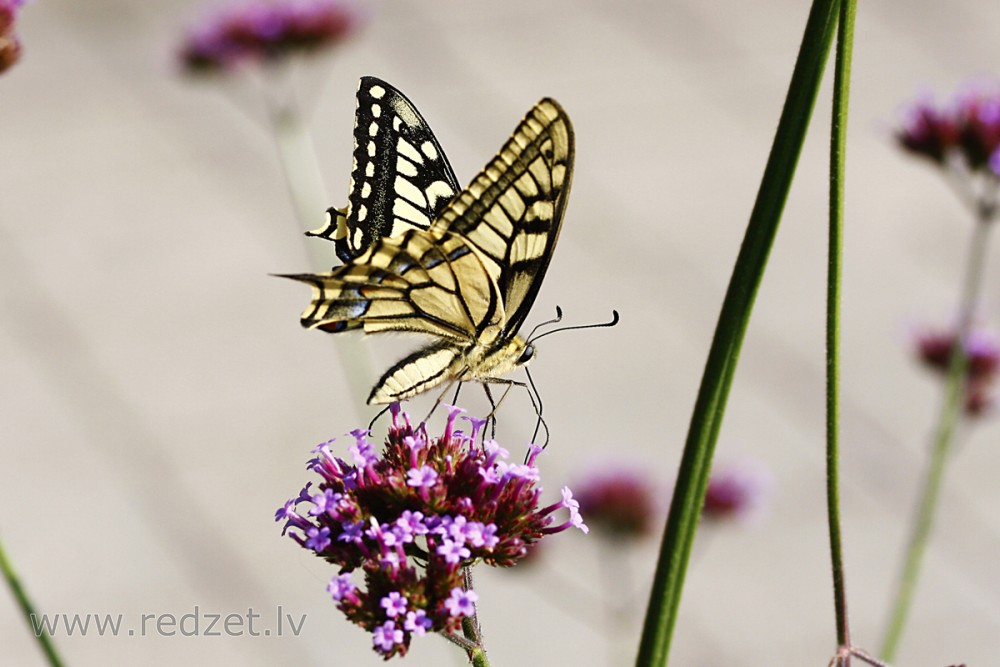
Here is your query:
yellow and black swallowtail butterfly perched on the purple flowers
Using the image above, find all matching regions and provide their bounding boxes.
[286,79,574,404]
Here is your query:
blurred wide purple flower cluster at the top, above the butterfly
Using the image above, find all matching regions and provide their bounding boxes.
[179,0,360,74]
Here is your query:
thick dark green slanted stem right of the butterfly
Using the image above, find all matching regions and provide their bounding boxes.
[636,0,840,666]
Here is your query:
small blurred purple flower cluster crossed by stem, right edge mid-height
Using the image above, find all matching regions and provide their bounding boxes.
[915,329,1000,416]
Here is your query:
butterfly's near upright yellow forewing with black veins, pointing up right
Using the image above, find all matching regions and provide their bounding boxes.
[430,98,574,340]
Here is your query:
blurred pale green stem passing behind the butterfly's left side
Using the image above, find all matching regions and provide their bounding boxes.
[270,104,377,419]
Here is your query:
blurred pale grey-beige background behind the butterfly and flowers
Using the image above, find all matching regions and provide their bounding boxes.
[0,0,1000,667]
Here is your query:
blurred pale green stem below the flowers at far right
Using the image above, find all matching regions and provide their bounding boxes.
[881,205,994,662]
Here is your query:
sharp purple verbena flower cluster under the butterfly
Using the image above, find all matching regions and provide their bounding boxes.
[275,405,587,659]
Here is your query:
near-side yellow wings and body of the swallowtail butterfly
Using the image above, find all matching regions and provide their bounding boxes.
[288,99,573,403]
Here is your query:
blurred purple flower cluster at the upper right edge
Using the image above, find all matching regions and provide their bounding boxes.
[896,88,1000,175]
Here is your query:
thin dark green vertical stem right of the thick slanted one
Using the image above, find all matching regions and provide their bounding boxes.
[826,0,857,665]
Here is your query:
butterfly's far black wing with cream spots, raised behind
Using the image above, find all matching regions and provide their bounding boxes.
[309,76,459,262]
